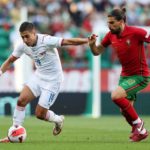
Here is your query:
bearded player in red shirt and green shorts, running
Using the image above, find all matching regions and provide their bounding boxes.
[89,8,150,142]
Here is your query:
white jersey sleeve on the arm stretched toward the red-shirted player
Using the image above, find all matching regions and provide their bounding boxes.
[43,35,63,48]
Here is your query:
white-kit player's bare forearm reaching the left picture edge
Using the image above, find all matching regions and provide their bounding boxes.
[0,55,18,74]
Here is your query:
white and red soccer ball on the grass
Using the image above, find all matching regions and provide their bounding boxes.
[8,125,27,143]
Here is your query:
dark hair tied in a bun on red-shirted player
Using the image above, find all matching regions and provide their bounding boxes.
[108,7,126,22]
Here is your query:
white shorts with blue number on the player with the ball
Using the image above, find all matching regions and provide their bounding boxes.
[25,74,61,109]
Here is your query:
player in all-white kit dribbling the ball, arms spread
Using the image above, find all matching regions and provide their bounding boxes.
[0,22,88,143]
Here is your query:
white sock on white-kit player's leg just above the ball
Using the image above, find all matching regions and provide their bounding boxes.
[13,106,25,126]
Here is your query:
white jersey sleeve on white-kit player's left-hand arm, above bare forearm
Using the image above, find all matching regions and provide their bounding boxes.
[12,43,24,58]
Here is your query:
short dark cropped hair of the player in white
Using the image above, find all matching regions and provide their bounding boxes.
[19,21,35,32]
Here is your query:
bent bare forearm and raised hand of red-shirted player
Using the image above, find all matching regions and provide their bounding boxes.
[88,34,104,56]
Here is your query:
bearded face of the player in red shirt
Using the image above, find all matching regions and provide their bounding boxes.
[108,17,122,34]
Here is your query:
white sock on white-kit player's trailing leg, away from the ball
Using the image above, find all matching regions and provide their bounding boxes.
[45,110,62,123]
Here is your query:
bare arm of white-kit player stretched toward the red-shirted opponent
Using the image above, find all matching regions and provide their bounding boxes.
[61,38,88,46]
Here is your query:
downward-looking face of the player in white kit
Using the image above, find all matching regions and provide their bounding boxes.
[20,30,37,46]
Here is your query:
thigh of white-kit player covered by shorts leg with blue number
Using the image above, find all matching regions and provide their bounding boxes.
[38,82,61,109]
